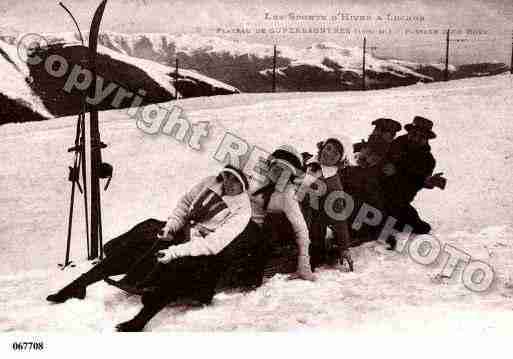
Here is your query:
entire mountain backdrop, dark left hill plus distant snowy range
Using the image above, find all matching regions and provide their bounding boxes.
[0,32,507,124]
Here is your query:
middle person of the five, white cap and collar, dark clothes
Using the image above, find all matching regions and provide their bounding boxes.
[301,138,353,271]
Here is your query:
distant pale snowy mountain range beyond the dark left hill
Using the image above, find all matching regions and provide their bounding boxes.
[39,32,507,92]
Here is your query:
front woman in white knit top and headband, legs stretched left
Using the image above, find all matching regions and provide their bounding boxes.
[47,166,251,324]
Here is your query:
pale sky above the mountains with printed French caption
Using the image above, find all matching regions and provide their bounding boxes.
[0,0,513,64]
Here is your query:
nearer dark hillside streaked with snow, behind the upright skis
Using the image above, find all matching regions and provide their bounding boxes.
[0,33,239,124]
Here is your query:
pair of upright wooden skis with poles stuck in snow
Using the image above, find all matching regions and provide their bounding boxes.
[60,0,112,268]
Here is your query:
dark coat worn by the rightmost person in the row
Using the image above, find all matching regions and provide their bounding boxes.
[382,135,436,206]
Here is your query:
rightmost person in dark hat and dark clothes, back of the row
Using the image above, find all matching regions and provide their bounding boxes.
[382,116,436,243]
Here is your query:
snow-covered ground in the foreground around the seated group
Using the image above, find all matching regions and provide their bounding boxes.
[0,76,513,335]
